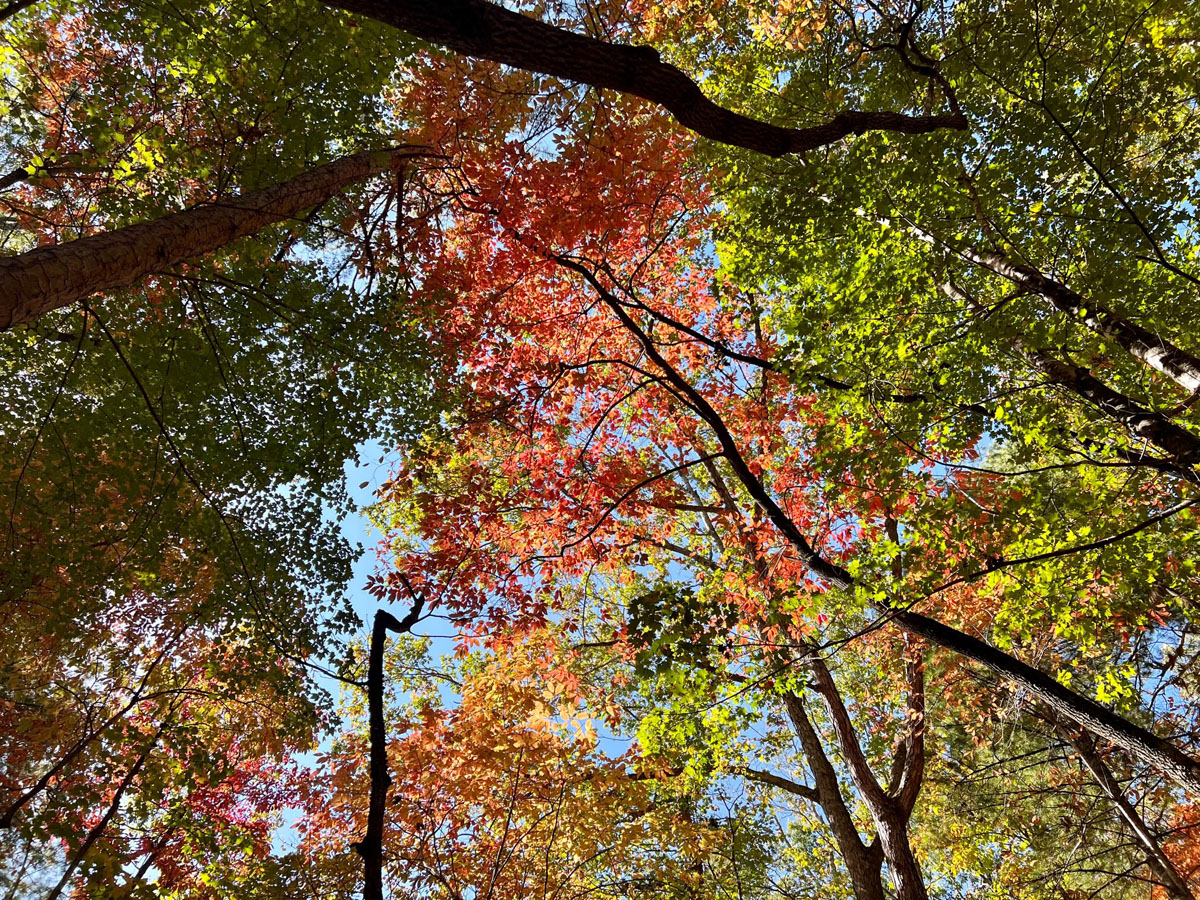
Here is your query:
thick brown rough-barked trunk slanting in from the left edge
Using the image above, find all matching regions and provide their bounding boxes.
[0,148,422,331]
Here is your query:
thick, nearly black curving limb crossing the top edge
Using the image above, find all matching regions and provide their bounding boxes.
[325,0,967,156]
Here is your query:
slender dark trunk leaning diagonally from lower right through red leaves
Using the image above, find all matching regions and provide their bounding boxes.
[564,257,1200,796]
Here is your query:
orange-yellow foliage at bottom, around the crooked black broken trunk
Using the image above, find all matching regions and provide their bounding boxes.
[302,631,709,896]
